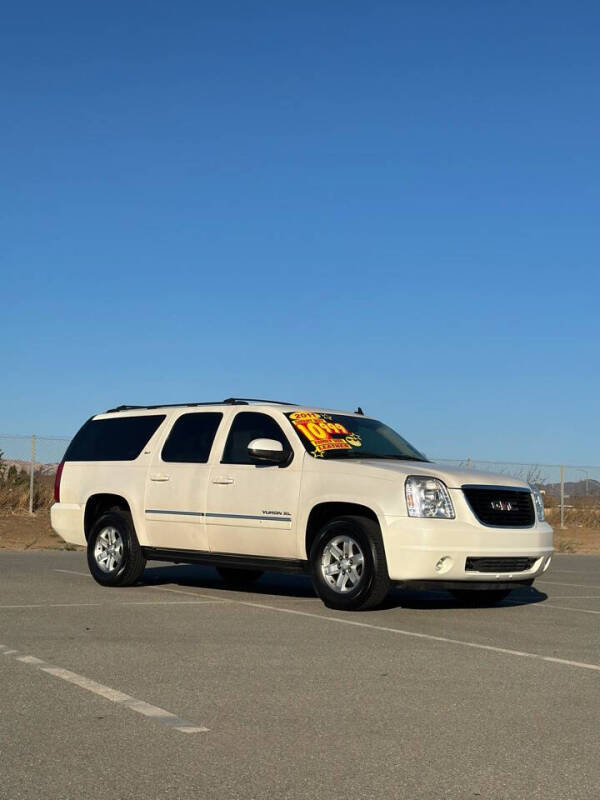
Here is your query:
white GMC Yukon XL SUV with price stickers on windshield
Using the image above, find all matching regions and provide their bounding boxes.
[51,398,553,609]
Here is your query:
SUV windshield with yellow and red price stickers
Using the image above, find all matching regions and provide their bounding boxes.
[286,411,427,461]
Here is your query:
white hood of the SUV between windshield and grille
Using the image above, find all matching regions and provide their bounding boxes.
[338,458,530,489]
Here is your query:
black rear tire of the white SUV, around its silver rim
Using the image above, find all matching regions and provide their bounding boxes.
[87,509,146,586]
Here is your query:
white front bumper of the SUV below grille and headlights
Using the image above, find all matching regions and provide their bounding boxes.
[383,517,554,585]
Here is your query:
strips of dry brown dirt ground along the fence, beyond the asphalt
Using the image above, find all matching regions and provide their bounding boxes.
[0,511,600,553]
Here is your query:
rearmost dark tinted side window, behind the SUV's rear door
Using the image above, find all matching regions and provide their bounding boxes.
[64,414,165,461]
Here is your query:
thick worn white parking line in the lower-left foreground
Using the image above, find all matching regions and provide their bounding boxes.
[0,644,208,733]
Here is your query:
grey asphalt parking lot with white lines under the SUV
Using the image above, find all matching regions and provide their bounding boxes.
[0,552,600,800]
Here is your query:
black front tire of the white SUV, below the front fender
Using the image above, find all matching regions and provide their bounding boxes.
[309,516,390,611]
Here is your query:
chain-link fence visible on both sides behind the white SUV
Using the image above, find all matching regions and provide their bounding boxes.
[0,434,600,529]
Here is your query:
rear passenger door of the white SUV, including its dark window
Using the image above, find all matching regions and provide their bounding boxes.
[144,411,223,551]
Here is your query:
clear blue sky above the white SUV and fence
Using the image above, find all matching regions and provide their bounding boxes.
[0,0,600,464]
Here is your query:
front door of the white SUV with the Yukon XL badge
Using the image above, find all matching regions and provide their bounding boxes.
[206,411,302,558]
